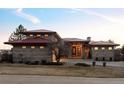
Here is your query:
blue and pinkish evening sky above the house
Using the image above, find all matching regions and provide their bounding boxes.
[0,8,124,49]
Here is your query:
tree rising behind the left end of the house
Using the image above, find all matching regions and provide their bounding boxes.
[9,25,26,41]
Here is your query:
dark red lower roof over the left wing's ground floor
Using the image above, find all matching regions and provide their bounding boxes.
[5,38,50,44]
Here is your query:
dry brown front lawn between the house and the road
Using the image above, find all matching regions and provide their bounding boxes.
[0,63,124,78]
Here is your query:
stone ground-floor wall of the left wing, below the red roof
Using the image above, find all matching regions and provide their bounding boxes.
[12,46,51,63]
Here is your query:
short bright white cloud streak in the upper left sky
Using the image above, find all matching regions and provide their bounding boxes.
[16,8,40,24]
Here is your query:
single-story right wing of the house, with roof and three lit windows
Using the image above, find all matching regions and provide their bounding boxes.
[89,41,119,61]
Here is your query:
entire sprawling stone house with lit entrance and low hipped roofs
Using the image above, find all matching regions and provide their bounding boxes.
[5,29,119,63]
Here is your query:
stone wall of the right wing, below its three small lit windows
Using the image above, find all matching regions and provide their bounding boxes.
[92,47,114,61]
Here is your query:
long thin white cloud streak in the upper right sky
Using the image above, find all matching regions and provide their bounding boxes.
[72,8,117,23]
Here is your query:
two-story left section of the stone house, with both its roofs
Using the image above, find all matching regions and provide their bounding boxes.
[5,29,61,63]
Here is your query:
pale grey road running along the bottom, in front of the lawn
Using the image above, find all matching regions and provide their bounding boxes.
[0,75,124,84]
